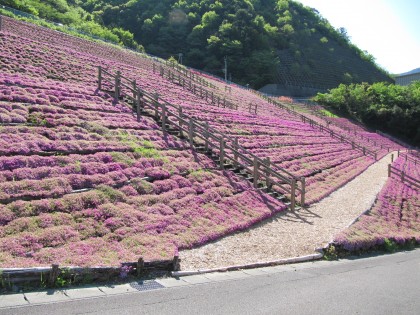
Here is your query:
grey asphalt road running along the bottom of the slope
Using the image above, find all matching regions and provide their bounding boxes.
[0,249,420,315]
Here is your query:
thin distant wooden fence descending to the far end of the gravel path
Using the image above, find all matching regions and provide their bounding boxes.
[265,97,378,160]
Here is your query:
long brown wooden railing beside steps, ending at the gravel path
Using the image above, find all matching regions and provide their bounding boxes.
[98,66,305,210]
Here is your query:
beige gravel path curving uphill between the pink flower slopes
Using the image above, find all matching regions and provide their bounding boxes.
[180,153,391,270]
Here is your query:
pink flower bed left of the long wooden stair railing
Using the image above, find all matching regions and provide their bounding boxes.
[0,24,286,267]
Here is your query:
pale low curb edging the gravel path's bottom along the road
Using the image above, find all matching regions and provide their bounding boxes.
[171,250,324,278]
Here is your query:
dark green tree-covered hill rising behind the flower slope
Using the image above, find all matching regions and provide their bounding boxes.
[0,0,392,89]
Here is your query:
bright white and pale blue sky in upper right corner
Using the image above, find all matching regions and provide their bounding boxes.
[297,0,420,74]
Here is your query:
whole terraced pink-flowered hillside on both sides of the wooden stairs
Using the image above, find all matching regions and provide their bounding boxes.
[0,18,414,267]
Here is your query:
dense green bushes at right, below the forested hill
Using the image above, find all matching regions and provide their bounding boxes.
[314,82,420,145]
